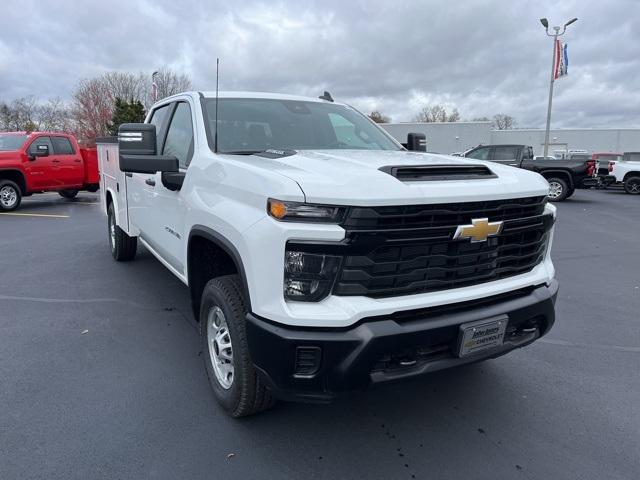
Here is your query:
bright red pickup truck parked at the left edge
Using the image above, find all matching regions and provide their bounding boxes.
[0,132,100,212]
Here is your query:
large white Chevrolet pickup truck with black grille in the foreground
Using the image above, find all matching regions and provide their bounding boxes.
[98,92,558,417]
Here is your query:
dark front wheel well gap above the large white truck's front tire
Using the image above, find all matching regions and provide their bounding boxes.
[187,234,239,321]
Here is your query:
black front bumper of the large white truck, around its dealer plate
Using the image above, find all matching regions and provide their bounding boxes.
[247,280,558,402]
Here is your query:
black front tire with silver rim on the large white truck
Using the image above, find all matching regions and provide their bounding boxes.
[200,275,274,418]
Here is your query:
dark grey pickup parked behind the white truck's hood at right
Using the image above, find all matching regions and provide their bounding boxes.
[465,145,597,202]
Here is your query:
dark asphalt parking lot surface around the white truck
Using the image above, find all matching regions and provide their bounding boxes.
[0,190,640,479]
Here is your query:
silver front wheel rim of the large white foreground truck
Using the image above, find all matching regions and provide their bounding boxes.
[207,306,235,390]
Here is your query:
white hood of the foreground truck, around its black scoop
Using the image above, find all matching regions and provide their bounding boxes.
[229,150,549,205]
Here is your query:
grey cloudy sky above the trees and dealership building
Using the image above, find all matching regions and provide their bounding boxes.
[0,0,640,127]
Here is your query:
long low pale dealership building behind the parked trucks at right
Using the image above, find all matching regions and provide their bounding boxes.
[381,122,640,155]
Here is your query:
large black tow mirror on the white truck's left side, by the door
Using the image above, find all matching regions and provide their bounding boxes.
[118,123,179,174]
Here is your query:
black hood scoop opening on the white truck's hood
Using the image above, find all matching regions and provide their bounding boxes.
[378,165,498,182]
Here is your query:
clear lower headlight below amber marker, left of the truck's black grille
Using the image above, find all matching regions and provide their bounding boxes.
[284,251,341,302]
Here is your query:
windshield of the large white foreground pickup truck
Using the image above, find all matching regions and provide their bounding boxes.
[205,98,400,154]
